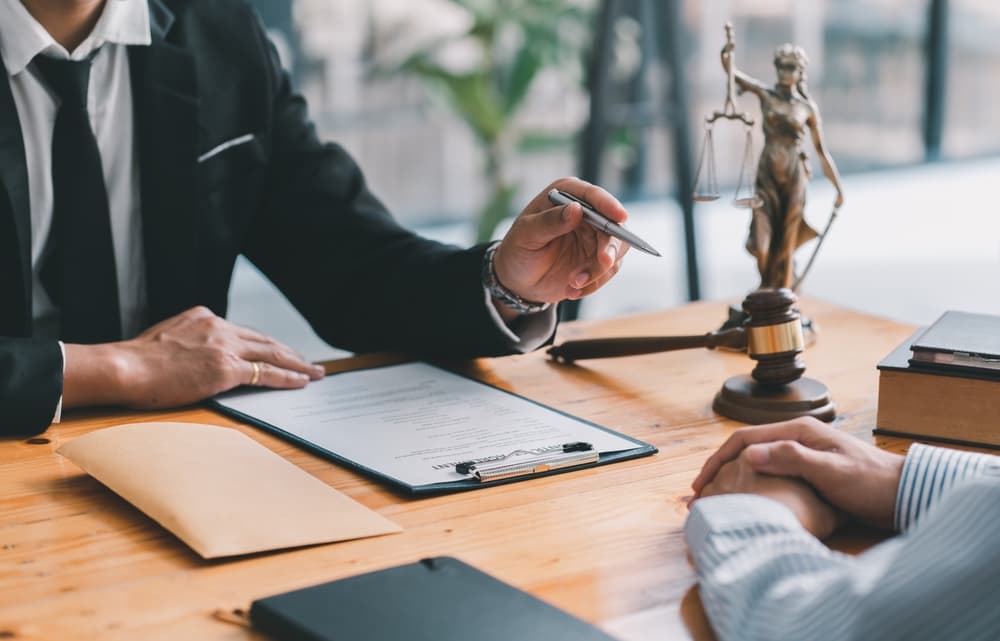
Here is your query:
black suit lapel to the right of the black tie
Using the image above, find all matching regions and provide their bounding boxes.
[129,0,200,323]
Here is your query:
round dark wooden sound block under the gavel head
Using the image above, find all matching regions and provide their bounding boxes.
[712,375,837,424]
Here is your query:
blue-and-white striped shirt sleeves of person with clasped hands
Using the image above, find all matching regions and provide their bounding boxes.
[684,444,1000,641]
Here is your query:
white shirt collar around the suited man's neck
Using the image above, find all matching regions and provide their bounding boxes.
[0,0,152,76]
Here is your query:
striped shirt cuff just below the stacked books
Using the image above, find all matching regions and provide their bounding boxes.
[894,443,1000,532]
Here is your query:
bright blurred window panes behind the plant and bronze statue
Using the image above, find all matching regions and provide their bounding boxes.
[253,0,1000,224]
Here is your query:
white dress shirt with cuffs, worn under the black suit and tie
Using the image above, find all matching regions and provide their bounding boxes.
[0,0,556,422]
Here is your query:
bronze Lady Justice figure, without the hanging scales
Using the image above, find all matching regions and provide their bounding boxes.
[722,40,844,289]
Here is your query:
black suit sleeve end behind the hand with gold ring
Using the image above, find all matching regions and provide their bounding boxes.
[0,337,63,437]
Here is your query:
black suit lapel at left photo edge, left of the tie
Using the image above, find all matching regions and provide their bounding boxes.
[0,51,31,336]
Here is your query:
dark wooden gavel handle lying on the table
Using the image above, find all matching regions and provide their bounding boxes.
[547,327,747,363]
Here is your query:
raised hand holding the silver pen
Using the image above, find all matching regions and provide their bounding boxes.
[494,178,660,303]
